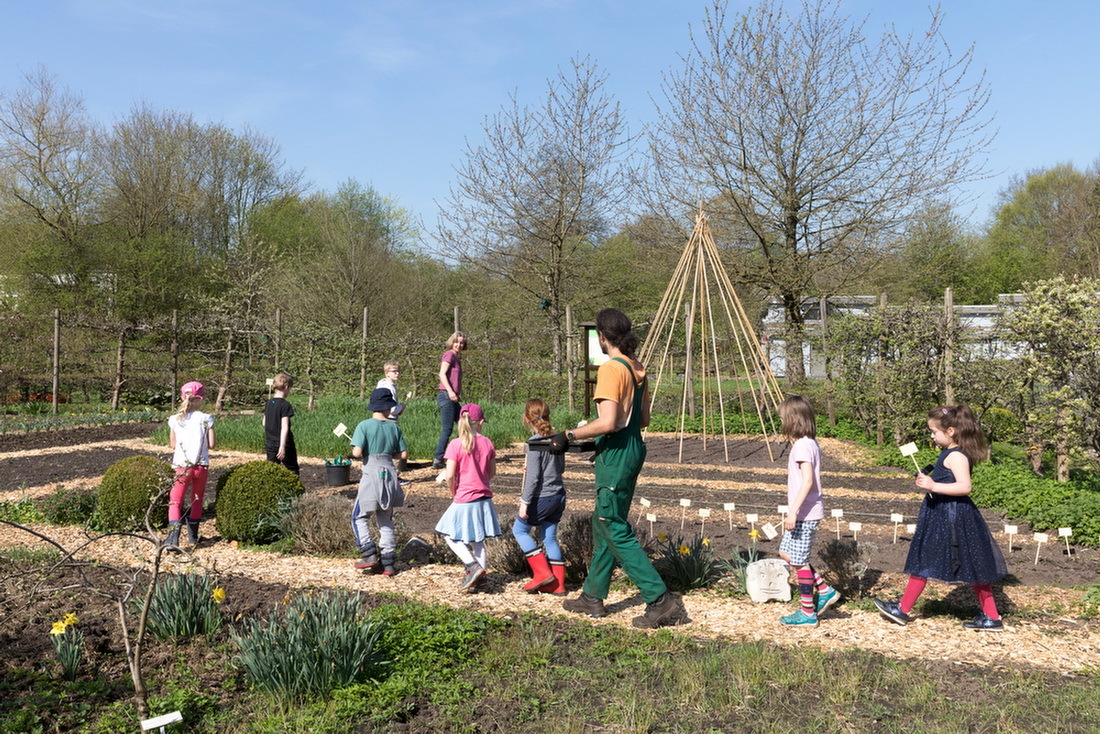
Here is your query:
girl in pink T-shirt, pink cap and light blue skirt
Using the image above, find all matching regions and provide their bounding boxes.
[436,403,501,589]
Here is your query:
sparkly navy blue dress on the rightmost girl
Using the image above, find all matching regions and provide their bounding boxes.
[905,447,1008,585]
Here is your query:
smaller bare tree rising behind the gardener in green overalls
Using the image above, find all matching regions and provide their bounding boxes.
[438,57,633,374]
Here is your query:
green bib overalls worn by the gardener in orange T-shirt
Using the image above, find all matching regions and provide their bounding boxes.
[584,357,668,604]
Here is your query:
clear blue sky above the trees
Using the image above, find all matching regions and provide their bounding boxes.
[0,0,1100,229]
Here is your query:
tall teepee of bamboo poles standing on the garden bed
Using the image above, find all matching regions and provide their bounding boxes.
[638,209,782,462]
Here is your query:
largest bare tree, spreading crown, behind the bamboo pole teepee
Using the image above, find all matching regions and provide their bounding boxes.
[652,0,992,383]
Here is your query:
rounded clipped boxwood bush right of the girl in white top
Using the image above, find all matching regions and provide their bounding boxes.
[215,461,306,544]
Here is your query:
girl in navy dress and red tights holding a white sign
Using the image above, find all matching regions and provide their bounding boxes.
[875,405,1008,632]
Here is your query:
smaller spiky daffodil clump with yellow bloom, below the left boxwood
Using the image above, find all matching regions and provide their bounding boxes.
[144,573,224,643]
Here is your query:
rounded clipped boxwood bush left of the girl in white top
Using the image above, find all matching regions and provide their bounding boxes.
[96,456,173,530]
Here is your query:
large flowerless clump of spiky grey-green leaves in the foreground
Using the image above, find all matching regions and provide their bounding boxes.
[230,589,388,702]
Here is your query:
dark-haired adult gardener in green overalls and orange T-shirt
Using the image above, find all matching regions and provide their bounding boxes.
[550,308,685,628]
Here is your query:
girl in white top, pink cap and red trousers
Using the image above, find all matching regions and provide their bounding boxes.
[164,382,213,549]
